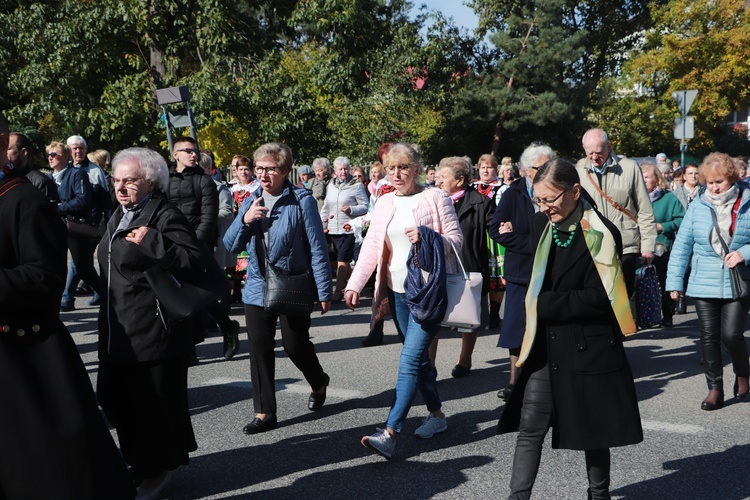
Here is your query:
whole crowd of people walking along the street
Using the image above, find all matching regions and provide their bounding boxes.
[0,106,750,499]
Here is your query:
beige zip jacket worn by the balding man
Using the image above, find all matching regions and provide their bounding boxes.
[576,152,657,254]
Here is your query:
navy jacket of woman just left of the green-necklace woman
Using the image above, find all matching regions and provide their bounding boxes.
[490,177,534,285]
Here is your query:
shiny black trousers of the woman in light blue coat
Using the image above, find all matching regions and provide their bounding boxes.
[695,299,750,390]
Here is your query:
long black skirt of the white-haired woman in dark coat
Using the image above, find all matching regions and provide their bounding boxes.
[96,356,198,479]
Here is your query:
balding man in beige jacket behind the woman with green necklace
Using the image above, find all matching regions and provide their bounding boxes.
[577,128,657,297]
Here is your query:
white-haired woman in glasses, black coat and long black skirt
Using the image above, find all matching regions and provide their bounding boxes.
[97,148,202,497]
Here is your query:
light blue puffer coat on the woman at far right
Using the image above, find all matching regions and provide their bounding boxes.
[666,183,750,299]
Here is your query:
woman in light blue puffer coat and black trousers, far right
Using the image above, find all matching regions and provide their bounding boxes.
[666,153,750,411]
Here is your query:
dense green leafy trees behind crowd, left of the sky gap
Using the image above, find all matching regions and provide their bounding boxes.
[0,0,472,162]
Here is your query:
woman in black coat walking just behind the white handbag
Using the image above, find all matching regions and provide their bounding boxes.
[430,156,495,377]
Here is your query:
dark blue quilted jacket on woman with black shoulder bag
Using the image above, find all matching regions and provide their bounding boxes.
[224,181,331,307]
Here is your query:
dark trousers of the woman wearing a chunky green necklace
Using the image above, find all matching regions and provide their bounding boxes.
[508,365,610,500]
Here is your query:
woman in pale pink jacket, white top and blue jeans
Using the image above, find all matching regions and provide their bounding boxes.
[344,144,463,458]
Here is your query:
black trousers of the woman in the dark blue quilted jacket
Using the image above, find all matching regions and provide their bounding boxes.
[245,305,326,413]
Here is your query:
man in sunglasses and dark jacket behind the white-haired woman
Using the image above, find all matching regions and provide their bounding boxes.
[167,137,240,364]
